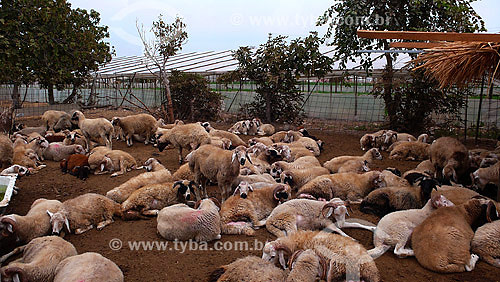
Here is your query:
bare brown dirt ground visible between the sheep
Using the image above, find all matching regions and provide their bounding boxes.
[3,111,500,281]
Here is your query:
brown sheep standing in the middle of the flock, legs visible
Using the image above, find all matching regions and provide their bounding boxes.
[189,145,248,202]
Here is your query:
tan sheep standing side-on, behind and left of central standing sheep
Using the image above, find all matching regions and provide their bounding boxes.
[158,123,210,164]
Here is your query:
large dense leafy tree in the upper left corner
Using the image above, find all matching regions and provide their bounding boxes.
[0,0,112,104]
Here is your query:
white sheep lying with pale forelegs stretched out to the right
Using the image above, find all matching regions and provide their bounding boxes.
[266,198,374,237]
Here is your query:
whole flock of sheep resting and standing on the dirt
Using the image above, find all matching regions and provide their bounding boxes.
[0,111,500,281]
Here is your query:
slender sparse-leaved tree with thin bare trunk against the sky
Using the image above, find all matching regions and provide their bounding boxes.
[136,15,188,122]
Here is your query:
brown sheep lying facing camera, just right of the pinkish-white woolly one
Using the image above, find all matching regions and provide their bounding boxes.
[220,181,291,236]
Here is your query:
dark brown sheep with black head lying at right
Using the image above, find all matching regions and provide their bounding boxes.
[360,178,438,217]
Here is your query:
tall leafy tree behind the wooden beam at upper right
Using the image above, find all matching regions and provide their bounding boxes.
[317,0,485,125]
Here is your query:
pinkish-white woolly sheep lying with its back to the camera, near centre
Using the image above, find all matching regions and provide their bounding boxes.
[157,198,221,242]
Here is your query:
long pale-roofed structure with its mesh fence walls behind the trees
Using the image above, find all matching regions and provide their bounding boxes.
[0,47,500,137]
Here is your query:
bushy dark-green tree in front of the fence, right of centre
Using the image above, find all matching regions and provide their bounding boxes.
[234,33,333,122]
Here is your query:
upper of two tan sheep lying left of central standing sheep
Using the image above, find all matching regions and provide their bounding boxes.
[106,158,173,203]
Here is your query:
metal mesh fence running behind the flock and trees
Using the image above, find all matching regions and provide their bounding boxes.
[0,74,500,137]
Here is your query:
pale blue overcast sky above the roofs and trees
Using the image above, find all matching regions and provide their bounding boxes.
[68,0,500,56]
